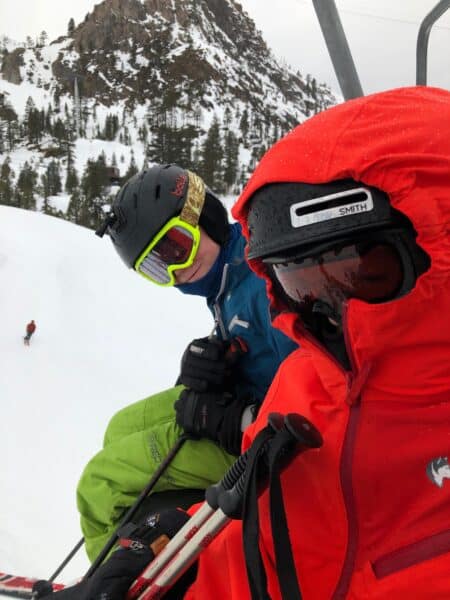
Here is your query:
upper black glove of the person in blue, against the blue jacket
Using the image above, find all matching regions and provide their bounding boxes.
[178,337,229,392]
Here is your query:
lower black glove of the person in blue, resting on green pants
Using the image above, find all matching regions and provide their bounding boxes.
[174,389,248,456]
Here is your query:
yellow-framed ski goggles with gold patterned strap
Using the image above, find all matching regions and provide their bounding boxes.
[134,171,205,287]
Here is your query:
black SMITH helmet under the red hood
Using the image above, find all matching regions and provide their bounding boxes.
[248,179,430,297]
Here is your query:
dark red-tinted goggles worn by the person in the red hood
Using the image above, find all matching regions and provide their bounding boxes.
[264,241,404,314]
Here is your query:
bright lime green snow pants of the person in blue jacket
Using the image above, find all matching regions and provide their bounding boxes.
[77,386,236,561]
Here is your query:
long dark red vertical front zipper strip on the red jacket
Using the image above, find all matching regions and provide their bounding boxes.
[332,304,361,600]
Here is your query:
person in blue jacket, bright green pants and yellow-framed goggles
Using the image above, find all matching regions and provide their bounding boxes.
[77,165,295,560]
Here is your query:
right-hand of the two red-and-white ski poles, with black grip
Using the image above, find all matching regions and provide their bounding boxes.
[132,413,322,600]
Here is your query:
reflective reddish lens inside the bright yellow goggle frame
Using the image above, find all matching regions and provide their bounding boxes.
[137,226,196,285]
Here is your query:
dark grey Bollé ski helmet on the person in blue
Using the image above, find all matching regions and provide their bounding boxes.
[97,164,229,268]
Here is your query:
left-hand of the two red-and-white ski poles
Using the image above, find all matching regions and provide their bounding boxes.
[127,413,282,600]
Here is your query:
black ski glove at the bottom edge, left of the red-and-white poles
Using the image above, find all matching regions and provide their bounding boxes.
[43,508,196,600]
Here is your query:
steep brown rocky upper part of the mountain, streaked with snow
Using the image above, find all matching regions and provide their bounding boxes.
[40,0,334,118]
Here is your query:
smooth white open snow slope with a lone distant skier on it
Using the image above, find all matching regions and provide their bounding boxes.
[0,206,212,582]
